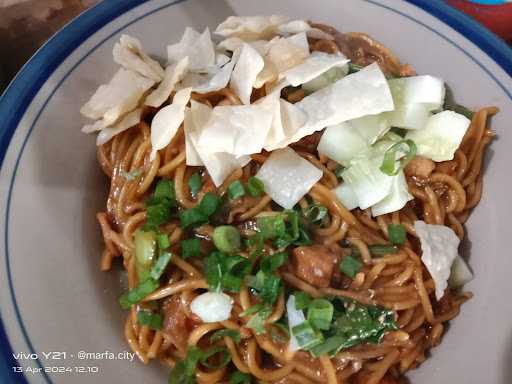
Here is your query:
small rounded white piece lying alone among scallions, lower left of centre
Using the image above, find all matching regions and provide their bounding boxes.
[190,292,233,323]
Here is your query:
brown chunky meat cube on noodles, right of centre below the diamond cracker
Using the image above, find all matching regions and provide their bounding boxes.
[293,245,338,288]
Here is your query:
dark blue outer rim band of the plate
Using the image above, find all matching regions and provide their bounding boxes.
[0,0,512,383]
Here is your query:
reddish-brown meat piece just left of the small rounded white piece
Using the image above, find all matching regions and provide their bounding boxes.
[163,295,193,354]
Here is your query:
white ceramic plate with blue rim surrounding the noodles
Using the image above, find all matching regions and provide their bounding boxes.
[0,0,512,384]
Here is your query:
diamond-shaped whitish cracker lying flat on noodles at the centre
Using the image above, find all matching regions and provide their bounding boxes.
[256,148,323,209]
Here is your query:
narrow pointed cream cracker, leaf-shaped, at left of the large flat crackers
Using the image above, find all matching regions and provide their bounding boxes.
[149,88,192,161]
